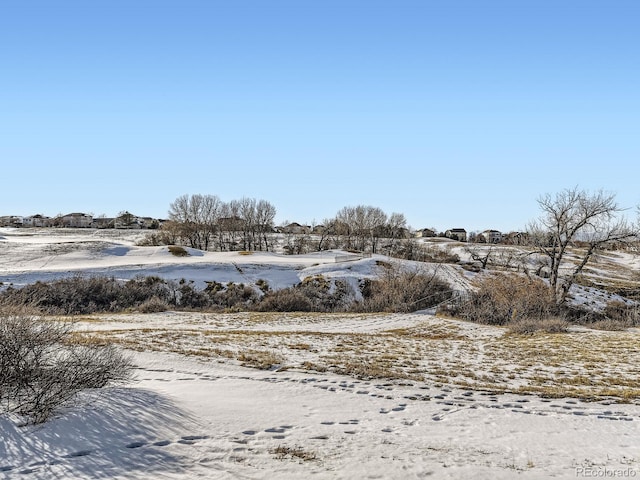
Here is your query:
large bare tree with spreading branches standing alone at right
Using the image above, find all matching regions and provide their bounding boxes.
[527,187,638,305]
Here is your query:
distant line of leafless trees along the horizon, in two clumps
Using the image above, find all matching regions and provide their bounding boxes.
[156,194,408,254]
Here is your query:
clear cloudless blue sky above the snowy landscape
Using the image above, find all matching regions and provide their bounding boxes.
[0,0,640,230]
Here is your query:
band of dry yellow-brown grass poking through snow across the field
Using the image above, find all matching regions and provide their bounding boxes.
[75,312,640,402]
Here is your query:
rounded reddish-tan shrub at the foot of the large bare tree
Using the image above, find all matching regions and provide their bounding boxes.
[451,274,556,325]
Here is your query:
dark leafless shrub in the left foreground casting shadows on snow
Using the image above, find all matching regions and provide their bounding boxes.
[0,309,132,423]
